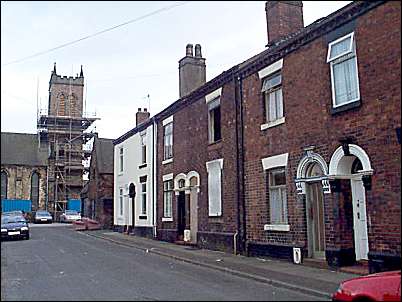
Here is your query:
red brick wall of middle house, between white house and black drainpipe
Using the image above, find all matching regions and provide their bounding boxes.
[157,82,237,251]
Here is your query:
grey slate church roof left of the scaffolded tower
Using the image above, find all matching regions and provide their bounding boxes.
[1,132,48,166]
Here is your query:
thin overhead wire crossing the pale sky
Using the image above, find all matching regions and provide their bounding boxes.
[1,1,191,66]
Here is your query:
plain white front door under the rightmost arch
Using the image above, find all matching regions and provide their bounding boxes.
[350,179,369,260]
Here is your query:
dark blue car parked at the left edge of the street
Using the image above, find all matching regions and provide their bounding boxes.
[1,215,29,239]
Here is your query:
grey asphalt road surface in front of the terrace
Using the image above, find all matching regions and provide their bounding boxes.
[1,224,317,301]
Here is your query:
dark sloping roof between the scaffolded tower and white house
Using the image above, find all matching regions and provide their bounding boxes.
[94,137,114,174]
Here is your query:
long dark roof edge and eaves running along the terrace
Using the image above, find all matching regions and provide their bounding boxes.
[113,1,386,145]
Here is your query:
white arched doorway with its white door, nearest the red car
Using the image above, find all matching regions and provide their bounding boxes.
[329,144,373,261]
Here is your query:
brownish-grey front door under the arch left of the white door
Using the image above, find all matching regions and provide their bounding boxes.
[307,182,325,258]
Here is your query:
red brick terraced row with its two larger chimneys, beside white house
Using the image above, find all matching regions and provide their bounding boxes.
[114,1,401,271]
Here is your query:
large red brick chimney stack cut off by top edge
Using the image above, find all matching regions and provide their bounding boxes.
[265,1,304,44]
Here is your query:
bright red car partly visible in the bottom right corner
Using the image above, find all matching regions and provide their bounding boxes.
[332,271,401,302]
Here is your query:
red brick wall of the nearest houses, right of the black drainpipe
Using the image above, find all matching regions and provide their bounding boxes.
[243,2,401,254]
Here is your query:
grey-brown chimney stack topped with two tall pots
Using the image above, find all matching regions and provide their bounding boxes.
[179,44,206,98]
